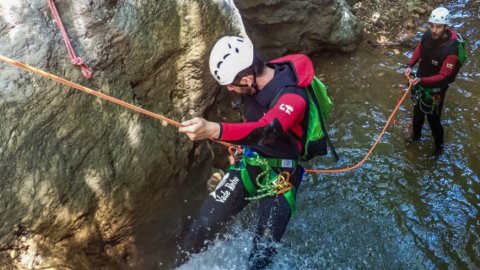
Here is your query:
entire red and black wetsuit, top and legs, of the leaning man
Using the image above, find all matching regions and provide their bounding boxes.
[182,58,313,269]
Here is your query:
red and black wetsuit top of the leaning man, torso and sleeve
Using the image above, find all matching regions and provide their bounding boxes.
[220,63,308,159]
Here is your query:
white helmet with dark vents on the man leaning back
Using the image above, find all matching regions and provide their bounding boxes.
[209,36,253,85]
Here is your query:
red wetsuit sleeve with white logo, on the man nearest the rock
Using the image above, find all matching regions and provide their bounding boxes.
[220,93,307,145]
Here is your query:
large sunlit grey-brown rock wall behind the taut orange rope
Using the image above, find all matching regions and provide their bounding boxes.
[0,0,241,269]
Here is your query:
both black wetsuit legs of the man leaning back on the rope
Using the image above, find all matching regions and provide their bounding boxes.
[182,166,303,269]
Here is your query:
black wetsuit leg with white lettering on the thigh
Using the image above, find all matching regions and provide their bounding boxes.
[182,170,249,253]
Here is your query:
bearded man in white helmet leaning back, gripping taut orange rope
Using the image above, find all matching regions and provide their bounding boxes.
[179,36,314,269]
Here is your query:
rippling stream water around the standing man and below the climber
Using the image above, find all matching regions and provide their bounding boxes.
[174,1,480,270]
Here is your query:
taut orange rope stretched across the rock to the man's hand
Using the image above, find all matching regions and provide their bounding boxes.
[0,55,231,146]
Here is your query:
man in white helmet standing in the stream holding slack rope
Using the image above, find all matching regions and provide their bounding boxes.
[404,7,460,156]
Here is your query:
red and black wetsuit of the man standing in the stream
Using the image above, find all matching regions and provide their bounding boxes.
[408,29,460,148]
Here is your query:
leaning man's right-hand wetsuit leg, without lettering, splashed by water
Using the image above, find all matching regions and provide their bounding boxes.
[248,168,303,270]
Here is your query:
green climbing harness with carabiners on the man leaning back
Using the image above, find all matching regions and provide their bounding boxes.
[229,148,298,215]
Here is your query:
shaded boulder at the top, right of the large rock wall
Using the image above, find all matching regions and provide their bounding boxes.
[234,0,362,59]
